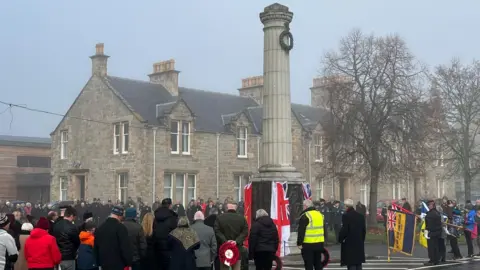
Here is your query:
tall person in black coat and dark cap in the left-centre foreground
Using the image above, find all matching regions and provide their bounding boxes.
[154,198,178,269]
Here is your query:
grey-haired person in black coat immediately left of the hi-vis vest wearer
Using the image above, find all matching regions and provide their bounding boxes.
[248,209,279,270]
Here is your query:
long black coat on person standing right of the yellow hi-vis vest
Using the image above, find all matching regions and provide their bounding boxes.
[338,207,367,266]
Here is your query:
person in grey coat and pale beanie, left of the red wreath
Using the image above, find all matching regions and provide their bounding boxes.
[191,211,217,270]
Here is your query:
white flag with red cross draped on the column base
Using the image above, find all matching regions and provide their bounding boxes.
[270,182,290,257]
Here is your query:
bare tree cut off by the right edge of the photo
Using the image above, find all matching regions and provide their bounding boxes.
[432,59,480,200]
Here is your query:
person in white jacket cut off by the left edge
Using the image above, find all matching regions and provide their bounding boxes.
[0,213,18,269]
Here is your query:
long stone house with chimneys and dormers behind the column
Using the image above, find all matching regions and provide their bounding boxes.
[51,44,454,203]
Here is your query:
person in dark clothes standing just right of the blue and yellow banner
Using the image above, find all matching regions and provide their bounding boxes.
[425,200,443,266]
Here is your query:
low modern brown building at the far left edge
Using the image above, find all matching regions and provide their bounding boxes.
[0,135,51,203]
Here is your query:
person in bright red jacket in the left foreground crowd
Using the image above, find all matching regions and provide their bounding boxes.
[24,217,62,270]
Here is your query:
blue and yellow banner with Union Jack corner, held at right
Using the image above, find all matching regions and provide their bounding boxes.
[387,206,416,256]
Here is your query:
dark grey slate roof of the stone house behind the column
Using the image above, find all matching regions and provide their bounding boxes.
[107,76,326,133]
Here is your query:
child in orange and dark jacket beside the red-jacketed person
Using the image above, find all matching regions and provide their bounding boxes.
[77,221,98,270]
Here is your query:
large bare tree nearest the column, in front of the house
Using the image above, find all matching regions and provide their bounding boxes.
[322,30,424,224]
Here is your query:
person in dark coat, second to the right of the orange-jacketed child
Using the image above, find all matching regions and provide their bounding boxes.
[123,207,147,270]
